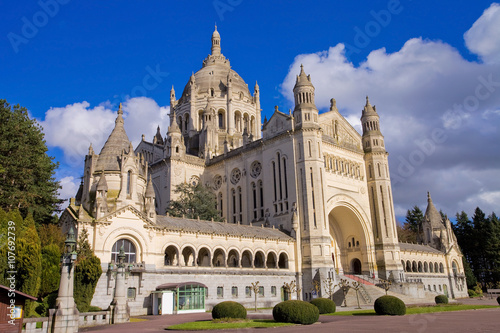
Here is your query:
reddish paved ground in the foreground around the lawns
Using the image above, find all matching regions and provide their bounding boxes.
[80,298,500,333]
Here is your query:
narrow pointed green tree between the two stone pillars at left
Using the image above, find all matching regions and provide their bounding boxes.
[73,229,102,312]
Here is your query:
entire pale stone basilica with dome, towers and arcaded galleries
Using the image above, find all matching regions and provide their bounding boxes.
[60,29,467,315]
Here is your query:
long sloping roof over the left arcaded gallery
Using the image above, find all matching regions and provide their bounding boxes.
[156,215,294,241]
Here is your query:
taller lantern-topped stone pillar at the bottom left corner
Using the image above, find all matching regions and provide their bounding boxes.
[51,227,79,333]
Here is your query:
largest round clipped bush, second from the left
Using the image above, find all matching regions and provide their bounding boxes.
[273,300,319,325]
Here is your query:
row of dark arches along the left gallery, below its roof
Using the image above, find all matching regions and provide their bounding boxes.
[164,245,288,269]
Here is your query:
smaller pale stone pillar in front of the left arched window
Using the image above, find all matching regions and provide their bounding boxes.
[110,246,130,324]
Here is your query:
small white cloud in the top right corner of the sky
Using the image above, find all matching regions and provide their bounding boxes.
[464,3,500,63]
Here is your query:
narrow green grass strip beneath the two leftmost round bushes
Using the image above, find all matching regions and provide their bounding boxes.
[165,319,295,331]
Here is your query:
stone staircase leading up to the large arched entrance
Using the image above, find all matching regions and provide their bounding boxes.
[333,275,437,307]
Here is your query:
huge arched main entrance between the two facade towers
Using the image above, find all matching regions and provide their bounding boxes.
[328,203,374,275]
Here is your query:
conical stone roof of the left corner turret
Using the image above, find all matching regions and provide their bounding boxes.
[96,104,130,171]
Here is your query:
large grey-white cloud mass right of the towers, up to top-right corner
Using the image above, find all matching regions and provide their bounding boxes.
[281,4,500,218]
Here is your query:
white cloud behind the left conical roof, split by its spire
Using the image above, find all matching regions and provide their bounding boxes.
[40,97,170,167]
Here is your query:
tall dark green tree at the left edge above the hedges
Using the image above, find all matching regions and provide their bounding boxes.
[0,99,62,223]
